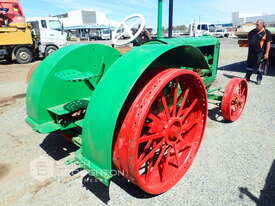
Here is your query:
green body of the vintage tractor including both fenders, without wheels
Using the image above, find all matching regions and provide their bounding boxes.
[26,0,249,193]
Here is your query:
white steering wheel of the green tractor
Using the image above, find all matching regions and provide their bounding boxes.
[112,14,145,46]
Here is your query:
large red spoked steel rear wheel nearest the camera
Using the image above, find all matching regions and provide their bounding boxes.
[113,69,208,194]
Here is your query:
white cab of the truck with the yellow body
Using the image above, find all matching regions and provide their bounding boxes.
[27,17,67,57]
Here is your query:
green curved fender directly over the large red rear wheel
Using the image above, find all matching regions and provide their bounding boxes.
[81,39,215,185]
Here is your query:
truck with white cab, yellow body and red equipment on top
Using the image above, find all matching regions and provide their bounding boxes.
[0,0,66,64]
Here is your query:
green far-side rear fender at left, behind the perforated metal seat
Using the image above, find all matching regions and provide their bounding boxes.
[26,44,121,133]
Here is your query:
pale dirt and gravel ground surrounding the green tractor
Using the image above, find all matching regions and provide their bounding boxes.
[0,40,275,206]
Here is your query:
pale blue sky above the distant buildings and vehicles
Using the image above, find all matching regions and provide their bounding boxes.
[21,0,275,27]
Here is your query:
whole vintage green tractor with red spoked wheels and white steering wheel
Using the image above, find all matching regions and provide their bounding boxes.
[26,0,248,194]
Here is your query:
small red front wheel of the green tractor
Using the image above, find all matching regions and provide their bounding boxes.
[221,78,248,122]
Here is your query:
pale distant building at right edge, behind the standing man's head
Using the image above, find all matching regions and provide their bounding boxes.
[232,12,275,26]
